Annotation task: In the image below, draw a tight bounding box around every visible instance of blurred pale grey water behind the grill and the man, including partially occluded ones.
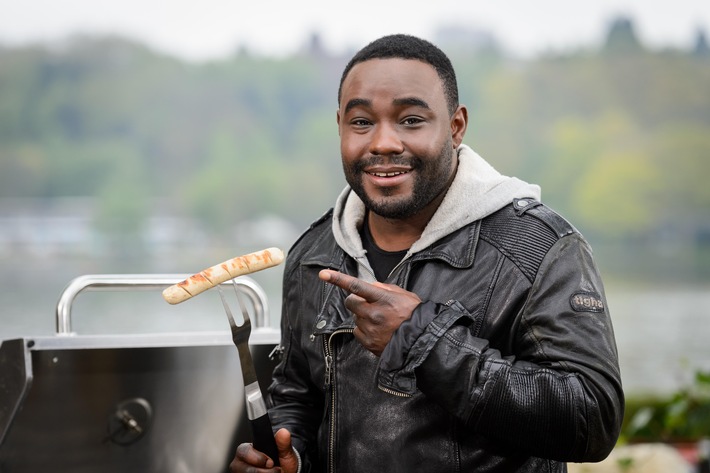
[0,251,710,394]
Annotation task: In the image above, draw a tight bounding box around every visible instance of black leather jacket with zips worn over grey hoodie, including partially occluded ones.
[270,200,624,473]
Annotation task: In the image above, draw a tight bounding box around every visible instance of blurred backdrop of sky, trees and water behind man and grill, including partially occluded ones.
[0,0,710,394]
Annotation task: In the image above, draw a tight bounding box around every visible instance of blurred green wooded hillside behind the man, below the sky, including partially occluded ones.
[0,21,710,276]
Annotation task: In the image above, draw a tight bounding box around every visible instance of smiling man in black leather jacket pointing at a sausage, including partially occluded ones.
[231,35,623,473]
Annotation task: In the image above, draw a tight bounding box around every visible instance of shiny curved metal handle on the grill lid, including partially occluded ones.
[57,274,269,335]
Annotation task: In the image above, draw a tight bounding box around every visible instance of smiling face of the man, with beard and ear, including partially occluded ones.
[338,59,465,219]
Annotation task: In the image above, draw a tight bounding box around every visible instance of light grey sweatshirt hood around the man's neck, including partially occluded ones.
[332,145,540,281]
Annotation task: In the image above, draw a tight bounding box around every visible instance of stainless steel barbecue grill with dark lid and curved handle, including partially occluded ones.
[0,275,279,473]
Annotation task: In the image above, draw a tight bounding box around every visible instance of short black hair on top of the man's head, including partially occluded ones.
[338,34,459,115]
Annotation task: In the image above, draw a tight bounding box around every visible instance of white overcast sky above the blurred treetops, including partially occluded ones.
[0,0,710,59]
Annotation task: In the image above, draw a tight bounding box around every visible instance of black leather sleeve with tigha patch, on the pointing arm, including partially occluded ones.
[379,232,624,462]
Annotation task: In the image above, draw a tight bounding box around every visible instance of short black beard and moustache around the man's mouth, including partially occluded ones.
[343,137,454,220]
